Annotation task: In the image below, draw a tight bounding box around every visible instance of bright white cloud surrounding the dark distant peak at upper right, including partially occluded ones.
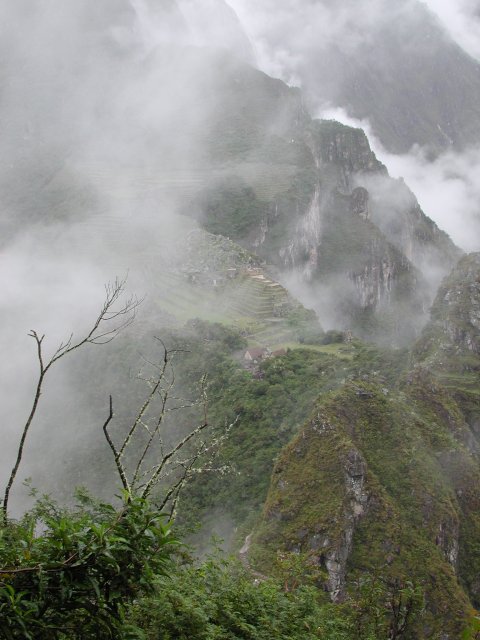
[231,0,480,251]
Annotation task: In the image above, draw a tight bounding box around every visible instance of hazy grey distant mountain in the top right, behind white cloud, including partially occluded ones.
[228,0,480,154]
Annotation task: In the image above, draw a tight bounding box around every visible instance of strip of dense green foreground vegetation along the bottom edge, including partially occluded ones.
[0,493,428,640]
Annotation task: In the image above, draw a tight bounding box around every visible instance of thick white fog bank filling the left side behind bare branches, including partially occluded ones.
[0,0,250,510]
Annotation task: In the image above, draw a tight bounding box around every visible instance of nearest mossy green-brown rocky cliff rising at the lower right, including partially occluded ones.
[251,255,480,640]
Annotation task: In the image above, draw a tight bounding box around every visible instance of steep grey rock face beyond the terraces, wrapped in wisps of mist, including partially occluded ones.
[274,121,450,342]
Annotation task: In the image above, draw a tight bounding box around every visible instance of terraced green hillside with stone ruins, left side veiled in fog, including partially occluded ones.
[58,210,321,348]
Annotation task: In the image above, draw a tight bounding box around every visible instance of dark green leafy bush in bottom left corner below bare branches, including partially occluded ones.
[0,495,176,640]
